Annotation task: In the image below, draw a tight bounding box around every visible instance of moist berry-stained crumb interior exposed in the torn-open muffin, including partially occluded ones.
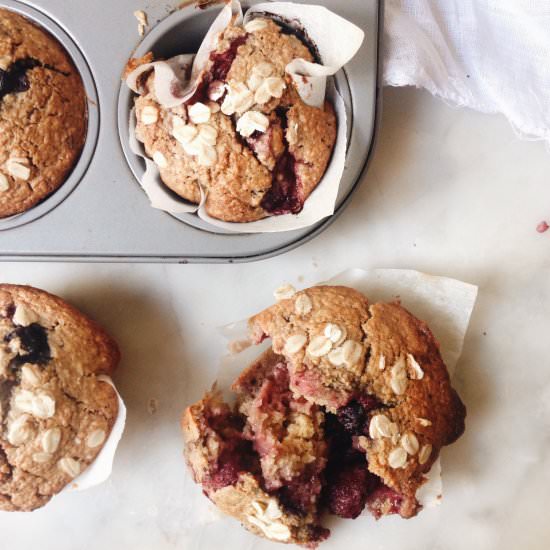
[187,356,426,546]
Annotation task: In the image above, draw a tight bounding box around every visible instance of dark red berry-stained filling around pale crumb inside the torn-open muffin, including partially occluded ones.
[204,378,412,540]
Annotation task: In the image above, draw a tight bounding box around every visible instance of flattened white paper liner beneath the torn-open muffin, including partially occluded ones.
[217,269,477,508]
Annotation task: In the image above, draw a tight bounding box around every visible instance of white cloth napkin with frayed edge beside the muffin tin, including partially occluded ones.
[384,0,550,147]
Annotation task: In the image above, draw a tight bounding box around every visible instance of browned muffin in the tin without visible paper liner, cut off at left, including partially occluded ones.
[0,9,87,218]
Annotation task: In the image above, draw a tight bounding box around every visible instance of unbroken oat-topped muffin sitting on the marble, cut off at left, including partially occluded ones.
[0,284,119,511]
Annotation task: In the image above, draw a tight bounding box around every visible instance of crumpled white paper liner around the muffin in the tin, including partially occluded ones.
[126,0,364,233]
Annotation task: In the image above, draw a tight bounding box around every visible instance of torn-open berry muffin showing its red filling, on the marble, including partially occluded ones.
[182,286,466,546]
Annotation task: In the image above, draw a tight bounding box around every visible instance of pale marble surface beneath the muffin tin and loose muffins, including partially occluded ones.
[0,89,550,550]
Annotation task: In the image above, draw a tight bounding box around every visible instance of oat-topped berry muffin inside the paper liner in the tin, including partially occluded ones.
[133,18,336,222]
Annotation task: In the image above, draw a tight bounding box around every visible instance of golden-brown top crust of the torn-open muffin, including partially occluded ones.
[249,286,466,504]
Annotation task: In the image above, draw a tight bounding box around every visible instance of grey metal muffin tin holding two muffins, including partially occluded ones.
[0,0,382,263]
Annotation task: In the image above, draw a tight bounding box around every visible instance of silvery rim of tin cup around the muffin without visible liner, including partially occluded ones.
[0,0,99,231]
